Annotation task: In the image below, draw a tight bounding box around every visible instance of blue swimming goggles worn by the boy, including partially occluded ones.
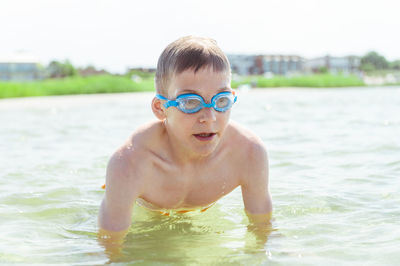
[156,91,237,114]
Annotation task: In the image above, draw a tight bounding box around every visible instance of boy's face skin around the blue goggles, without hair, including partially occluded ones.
[165,68,232,157]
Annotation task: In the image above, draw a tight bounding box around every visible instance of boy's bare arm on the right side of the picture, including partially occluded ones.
[241,143,272,218]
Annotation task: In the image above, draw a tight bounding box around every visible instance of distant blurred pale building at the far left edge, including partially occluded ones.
[0,54,42,81]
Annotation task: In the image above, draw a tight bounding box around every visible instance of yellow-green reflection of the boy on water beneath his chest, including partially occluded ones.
[101,206,272,265]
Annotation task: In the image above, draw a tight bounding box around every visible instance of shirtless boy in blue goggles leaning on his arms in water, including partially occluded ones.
[99,36,272,234]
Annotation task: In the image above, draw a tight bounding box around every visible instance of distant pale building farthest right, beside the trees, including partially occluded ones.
[305,55,361,73]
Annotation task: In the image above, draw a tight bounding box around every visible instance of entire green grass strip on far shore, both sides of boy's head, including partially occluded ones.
[0,74,365,98]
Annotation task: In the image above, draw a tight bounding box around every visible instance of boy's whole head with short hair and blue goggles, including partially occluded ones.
[152,36,236,157]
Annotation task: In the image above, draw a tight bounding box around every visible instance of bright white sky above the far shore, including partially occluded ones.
[0,0,400,73]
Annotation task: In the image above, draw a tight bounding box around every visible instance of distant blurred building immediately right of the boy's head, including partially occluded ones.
[228,55,304,75]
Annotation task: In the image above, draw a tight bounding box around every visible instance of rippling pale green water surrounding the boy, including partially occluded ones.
[0,87,400,265]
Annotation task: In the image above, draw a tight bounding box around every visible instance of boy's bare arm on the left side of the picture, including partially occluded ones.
[99,153,139,234]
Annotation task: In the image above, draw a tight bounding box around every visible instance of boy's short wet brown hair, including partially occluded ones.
[155,36,231,97]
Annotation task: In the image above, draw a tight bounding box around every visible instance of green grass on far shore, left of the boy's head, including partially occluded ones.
[0,75,154,98]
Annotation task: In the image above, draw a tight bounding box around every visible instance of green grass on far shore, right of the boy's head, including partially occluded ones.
[232,74,365,88]
